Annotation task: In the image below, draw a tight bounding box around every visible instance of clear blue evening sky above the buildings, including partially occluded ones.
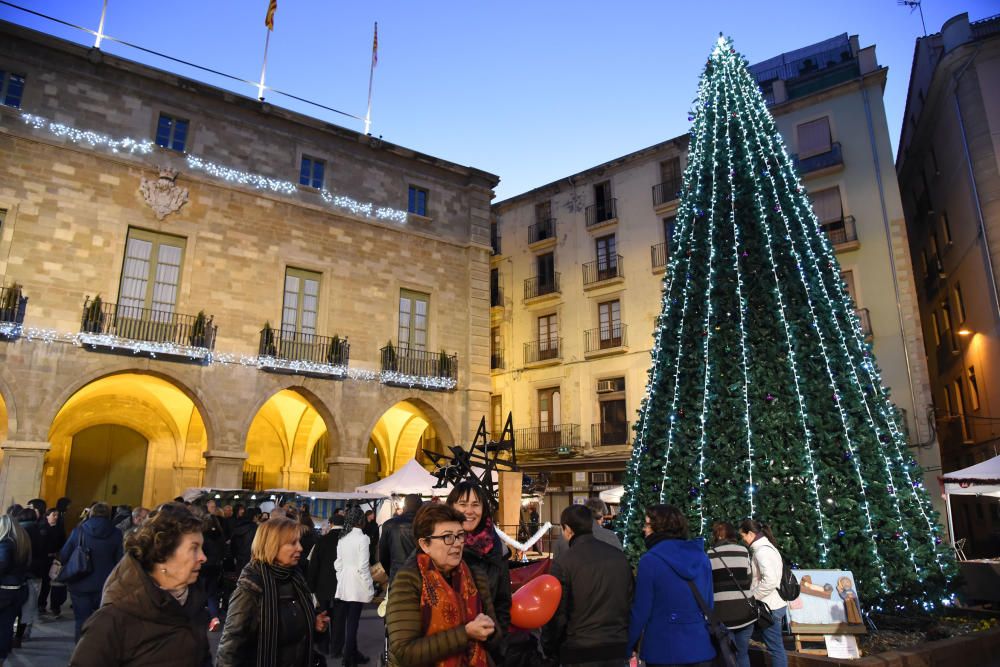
[0,0,1000,199]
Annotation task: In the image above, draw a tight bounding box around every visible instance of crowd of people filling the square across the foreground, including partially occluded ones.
[0,483,787,667]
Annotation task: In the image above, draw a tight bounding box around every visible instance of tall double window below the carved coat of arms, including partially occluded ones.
[118,229,185,321]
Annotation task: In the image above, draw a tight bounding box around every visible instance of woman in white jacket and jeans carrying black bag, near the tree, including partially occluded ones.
[740,519,788,667]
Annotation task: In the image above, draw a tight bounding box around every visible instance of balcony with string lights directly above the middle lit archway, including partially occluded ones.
[257,326,351,379]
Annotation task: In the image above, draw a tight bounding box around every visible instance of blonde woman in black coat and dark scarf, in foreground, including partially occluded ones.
[216,517,328,667]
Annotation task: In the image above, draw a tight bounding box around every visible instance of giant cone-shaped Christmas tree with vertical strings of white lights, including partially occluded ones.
[619,37,954,607]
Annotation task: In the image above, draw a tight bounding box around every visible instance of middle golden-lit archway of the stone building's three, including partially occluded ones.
[243,389,333,491]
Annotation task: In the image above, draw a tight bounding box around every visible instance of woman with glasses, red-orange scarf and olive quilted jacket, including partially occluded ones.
[386,503,502,667]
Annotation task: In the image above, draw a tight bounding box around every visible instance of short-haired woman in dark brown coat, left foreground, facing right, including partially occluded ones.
[69,502,212,667]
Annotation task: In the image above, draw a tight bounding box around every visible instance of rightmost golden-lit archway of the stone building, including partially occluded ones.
[365,399,455,481]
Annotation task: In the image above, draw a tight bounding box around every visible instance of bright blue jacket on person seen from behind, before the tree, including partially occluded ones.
[628,538,715,664]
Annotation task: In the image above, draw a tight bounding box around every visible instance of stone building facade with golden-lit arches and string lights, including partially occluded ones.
[0,23,498,505]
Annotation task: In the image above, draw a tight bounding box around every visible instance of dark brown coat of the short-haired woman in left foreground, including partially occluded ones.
[69,555,212,667]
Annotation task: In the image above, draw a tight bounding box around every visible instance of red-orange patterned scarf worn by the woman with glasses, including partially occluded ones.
[417,553,488,667]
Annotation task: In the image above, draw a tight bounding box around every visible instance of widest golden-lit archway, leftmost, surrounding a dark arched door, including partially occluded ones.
[42,372,208,507]
